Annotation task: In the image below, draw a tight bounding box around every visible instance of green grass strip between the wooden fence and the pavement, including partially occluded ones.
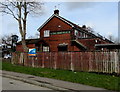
[2,62,120,91]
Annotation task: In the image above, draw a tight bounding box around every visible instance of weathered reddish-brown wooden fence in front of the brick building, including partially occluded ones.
[12,51,120,74]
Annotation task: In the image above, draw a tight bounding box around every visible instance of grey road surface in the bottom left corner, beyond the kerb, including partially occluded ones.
[0,76,52,90]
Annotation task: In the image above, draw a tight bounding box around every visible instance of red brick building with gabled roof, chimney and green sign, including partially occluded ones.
[16,10,113,52]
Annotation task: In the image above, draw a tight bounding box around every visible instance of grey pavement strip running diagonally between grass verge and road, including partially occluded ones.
[1,71,113,92]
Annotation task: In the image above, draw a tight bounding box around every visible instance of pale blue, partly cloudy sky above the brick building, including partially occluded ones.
[0,1,118,41]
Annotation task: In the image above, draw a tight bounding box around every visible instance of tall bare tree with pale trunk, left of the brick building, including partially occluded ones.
[0,0,43,52]
